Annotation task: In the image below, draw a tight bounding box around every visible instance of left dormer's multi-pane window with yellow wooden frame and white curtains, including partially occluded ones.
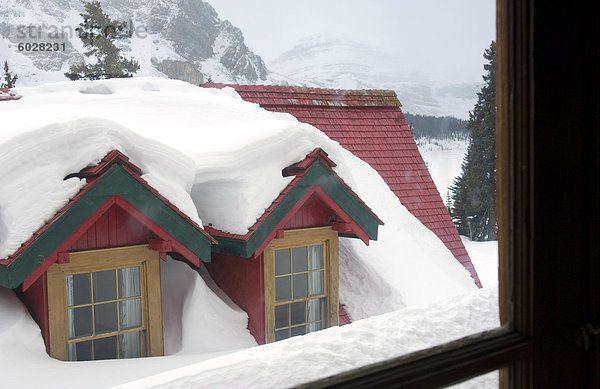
[48,246,163,361]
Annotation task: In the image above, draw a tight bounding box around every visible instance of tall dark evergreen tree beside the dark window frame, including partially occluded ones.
[450,42,498,240]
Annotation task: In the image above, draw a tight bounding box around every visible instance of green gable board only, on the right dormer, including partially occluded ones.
[212,161,379,258]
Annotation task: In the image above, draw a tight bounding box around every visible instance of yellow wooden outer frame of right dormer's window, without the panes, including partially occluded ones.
[263,227,340,343]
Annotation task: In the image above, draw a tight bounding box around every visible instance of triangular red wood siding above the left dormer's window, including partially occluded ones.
[69,204,155,251]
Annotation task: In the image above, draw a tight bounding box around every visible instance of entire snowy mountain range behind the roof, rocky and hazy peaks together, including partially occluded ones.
[0,0,481,119]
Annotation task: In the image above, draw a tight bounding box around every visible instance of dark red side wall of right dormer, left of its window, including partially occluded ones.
[205,253,265,344]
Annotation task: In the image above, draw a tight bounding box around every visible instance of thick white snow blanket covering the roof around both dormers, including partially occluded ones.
[0,78,474,310]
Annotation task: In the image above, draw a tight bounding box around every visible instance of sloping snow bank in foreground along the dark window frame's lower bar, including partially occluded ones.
[118,289,499,389]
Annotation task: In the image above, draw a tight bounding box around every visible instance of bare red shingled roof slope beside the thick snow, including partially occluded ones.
[203,84,481,287]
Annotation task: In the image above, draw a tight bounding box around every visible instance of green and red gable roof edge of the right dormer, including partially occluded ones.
[206,148,383,258]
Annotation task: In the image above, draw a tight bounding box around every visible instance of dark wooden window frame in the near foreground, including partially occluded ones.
[305,0,600,389]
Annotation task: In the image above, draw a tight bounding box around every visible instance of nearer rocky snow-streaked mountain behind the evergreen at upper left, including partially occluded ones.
[0,0,267,85]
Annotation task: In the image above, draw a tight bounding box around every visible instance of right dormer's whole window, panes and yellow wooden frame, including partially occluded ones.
[264,227,339,342]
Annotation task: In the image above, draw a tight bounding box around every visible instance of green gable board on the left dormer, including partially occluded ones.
[0,164,212,289]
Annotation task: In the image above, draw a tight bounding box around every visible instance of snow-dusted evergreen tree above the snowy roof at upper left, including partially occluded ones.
[65,1,140,80]
